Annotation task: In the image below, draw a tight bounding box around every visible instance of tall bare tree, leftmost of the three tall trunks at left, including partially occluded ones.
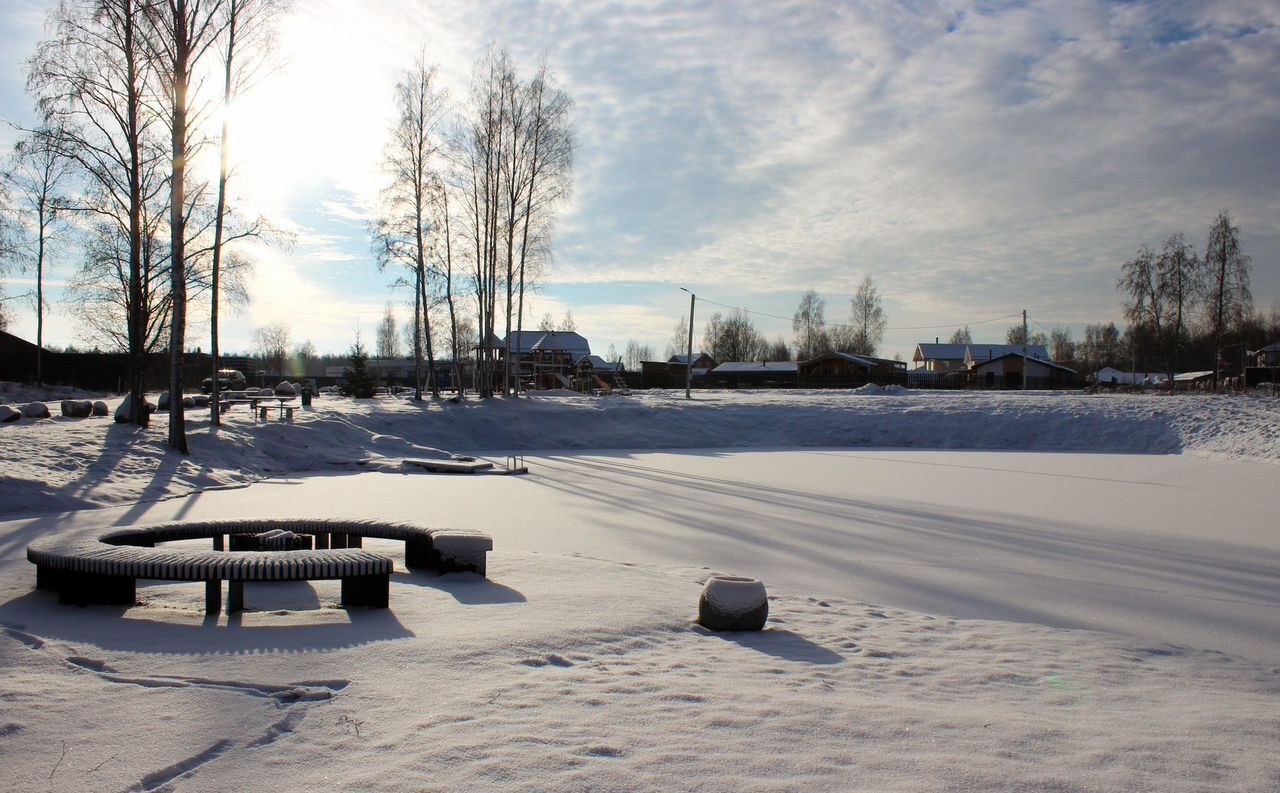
[27,0,163,425]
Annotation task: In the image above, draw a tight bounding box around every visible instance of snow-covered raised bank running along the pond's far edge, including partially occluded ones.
[0,389,1280,514]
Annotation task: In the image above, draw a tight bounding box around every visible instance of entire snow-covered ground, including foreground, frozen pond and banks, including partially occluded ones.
[0,393,1280,792]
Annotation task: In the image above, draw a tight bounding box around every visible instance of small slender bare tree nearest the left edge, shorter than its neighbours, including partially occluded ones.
[4,128,72,384]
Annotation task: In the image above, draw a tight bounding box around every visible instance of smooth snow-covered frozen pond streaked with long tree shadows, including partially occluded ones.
[10,450,1280,664]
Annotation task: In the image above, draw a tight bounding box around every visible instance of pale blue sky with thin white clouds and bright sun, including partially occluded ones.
[0,0,1280,359]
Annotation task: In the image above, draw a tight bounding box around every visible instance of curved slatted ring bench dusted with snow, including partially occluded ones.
[27,519,493,614]
